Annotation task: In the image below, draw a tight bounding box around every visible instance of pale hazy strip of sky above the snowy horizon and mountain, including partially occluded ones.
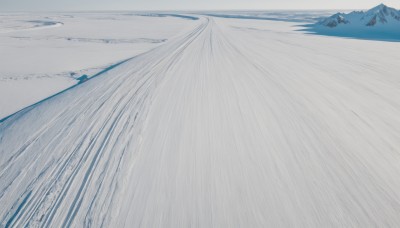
[0,0,400,11]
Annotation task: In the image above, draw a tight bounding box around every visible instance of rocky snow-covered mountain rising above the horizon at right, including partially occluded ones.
[319,4,400,28]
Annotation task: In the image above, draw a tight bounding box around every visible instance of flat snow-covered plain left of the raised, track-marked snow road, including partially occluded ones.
[0,12,195,119]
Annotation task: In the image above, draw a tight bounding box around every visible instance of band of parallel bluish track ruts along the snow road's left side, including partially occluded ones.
[1,17,207,226]
